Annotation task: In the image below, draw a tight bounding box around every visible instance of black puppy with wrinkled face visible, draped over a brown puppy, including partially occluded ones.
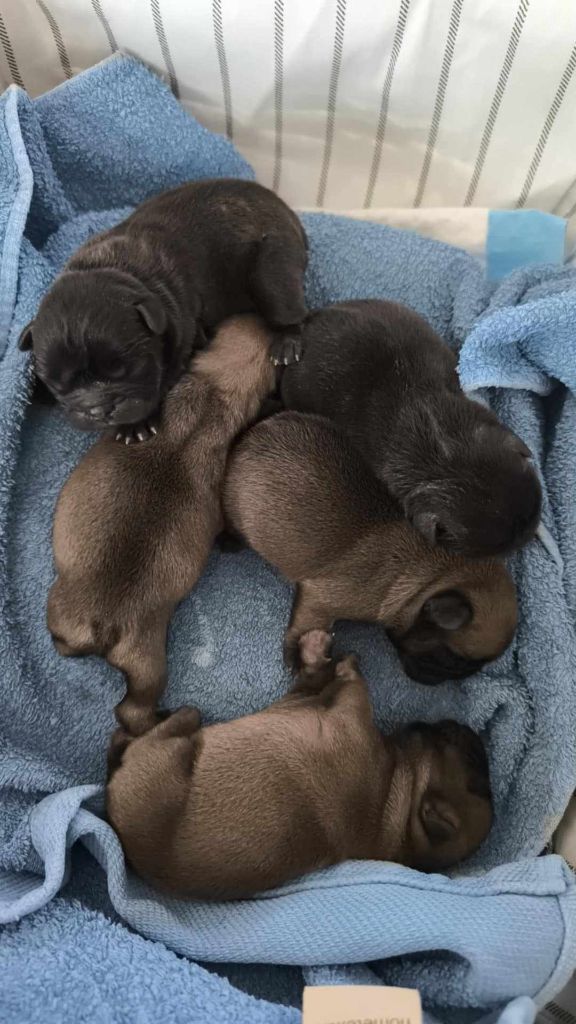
[20,178,307,441]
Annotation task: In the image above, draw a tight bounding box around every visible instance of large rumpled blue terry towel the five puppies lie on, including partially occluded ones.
[0,57,576,1022]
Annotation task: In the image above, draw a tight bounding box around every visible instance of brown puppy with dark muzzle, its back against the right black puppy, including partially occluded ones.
[223,413,517,683]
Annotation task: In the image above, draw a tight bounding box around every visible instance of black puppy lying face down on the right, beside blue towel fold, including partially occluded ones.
[282,300,541,557]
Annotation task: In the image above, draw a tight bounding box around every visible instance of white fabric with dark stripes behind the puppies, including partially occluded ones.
[0,0,576,216]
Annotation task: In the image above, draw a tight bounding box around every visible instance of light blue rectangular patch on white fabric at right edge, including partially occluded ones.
[486,210,566,281]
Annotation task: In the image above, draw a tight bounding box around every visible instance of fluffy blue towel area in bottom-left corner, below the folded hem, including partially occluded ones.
[0,899,535,1024]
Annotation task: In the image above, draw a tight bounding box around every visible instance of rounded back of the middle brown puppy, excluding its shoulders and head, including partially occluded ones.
[223,413,401,580]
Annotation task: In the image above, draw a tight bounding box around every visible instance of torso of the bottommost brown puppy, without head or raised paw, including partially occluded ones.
[107,696,384,899]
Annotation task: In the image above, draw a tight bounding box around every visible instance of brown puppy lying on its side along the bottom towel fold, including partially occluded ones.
[107,631,492,899]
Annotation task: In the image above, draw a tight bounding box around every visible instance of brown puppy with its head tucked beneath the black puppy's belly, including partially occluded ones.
[48,315,275,734]
